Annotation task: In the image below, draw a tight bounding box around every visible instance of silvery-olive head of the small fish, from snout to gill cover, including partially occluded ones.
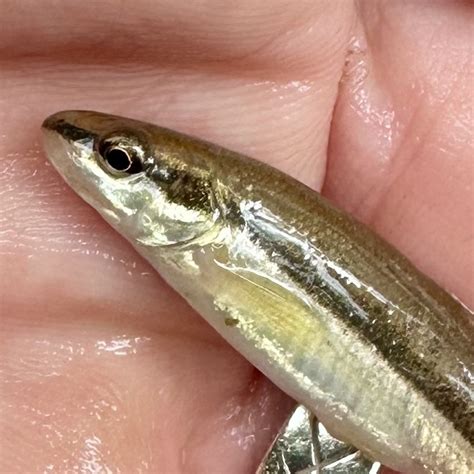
[42,111,220,247]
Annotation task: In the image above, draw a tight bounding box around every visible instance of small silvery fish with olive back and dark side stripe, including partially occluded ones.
[43,111,474,474]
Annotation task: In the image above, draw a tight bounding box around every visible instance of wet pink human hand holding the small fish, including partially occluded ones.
[0,0,474,474]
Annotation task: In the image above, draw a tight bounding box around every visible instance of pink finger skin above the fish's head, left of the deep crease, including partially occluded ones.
[0,0,353,187]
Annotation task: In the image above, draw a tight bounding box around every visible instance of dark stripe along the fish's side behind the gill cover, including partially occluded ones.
[246,216,474,444]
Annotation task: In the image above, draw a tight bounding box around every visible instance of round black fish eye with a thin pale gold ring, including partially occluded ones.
[98,139,143,176]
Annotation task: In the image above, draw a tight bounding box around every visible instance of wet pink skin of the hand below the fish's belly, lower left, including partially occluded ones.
[0,131,291,472]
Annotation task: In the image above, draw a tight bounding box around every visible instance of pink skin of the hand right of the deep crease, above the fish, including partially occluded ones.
[324,2,474,307]
